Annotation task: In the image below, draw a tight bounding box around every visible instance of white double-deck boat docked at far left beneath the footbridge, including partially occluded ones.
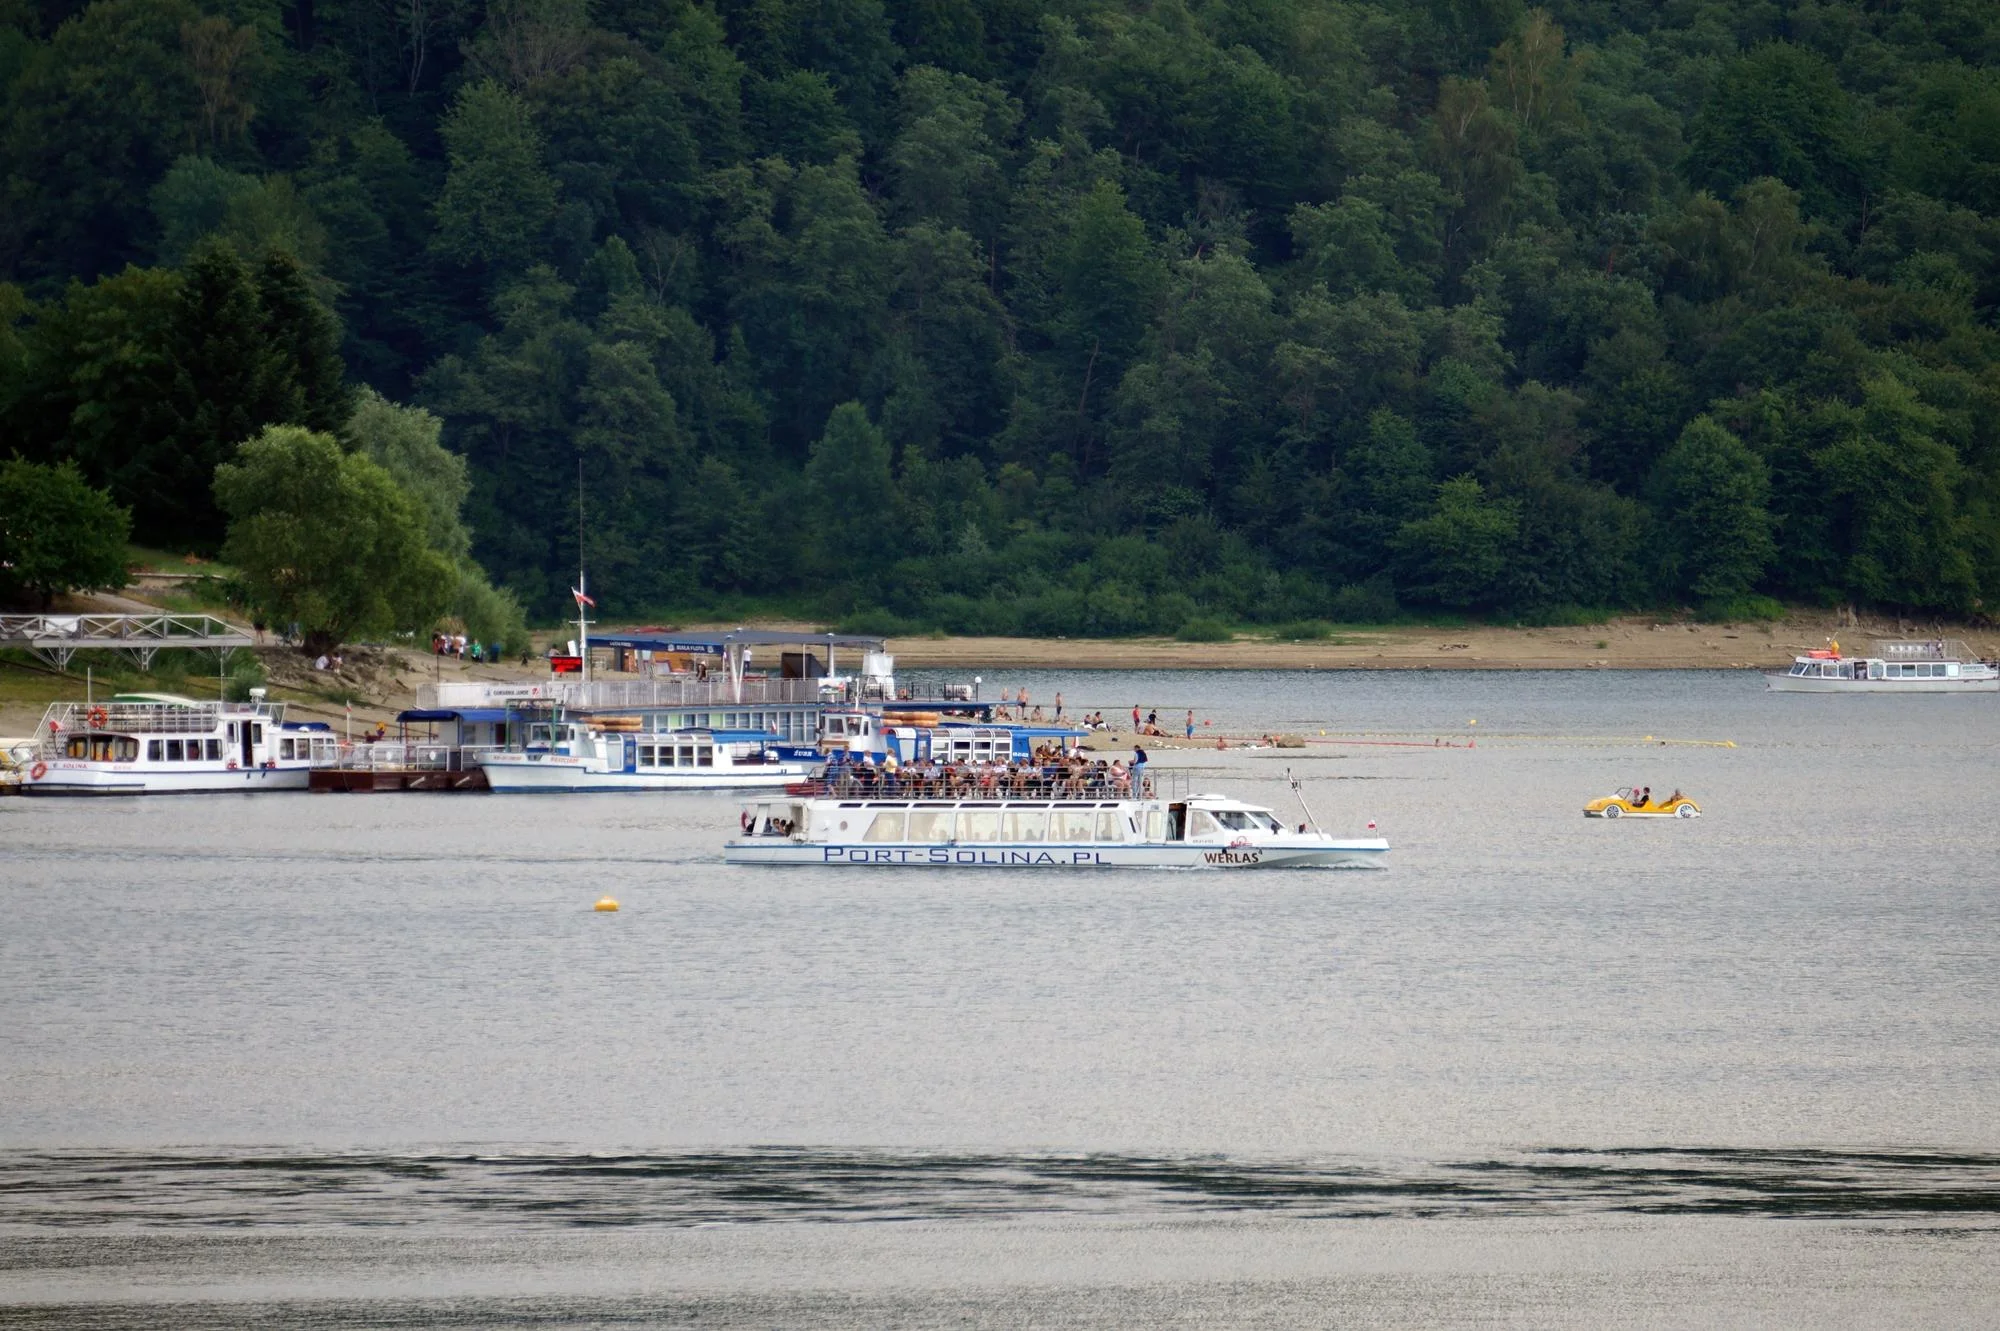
[22,689,338,795]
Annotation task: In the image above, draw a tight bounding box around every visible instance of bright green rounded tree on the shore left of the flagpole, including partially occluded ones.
[214,426,458,656]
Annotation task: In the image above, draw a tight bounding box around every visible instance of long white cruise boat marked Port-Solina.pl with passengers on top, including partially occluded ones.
[722,777,1388,869]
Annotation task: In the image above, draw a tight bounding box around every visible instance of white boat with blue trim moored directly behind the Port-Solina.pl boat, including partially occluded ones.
[478,717,820,793]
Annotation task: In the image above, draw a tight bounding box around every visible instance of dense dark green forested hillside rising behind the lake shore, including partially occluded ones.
[0,0,2000,634]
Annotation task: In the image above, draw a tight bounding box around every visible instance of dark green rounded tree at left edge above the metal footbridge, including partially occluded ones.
[0,458,132,610]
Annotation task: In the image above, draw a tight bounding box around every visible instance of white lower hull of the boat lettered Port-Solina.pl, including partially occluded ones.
[722,837,1388,869]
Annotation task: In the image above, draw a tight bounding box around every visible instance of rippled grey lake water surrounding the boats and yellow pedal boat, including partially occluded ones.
[0,671,2000,1327]
